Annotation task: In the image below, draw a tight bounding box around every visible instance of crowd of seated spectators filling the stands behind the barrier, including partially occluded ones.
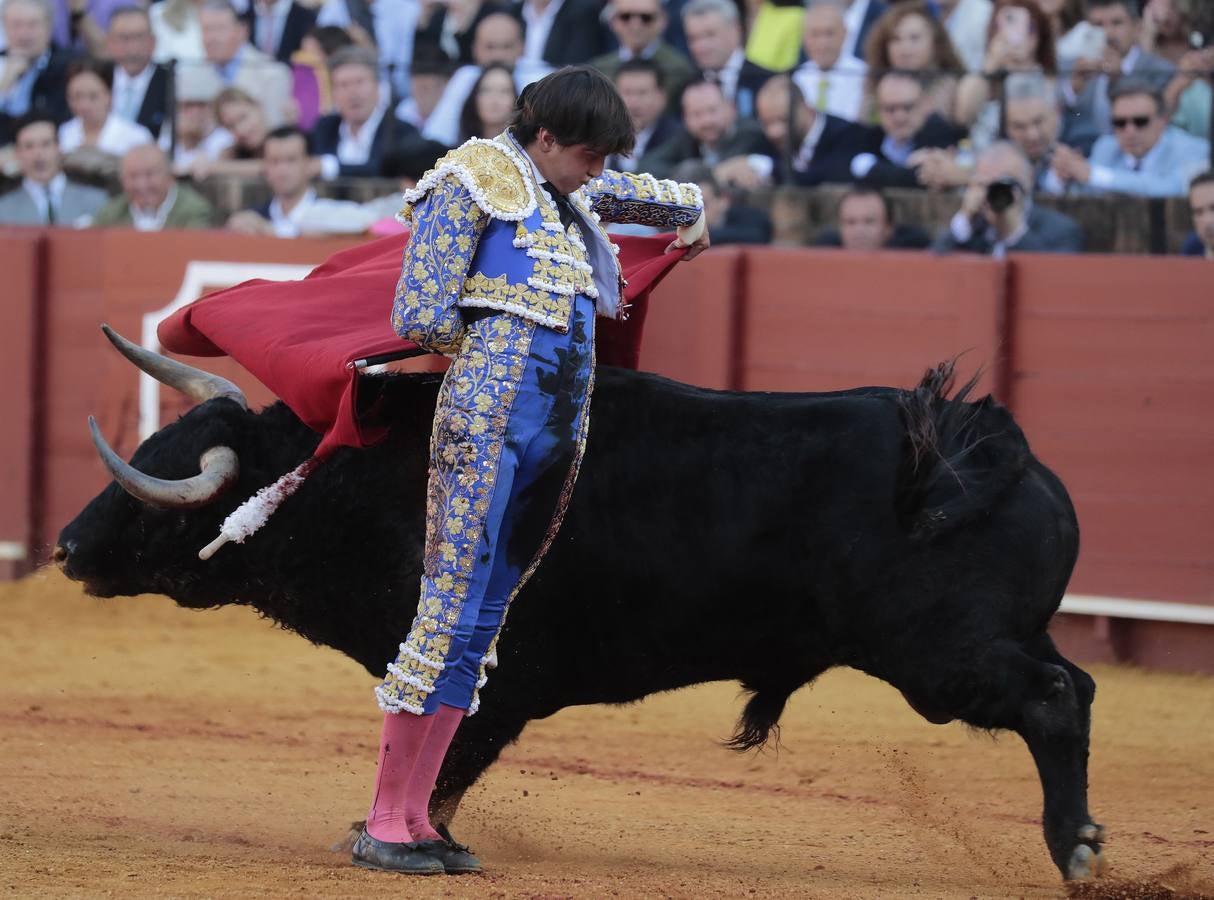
[0,0,1214,256]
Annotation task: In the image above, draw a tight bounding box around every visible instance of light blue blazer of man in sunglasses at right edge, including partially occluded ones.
[1083,125,1210,197]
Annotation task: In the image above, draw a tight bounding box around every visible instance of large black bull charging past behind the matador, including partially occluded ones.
[56,357,1104,878]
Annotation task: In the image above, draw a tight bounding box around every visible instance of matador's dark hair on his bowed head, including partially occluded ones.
[510,66,636,155]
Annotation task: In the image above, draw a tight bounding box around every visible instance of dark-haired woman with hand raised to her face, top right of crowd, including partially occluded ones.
[954,0,1057,151]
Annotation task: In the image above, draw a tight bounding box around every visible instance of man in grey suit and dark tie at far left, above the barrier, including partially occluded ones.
[0,113,107,227]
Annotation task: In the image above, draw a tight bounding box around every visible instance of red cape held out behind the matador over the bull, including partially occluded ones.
[157,234,685,457]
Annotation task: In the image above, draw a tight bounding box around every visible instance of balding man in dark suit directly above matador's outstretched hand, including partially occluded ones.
[636,80,771,179]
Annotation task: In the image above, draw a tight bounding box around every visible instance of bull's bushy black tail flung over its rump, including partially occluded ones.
[896,360,1031,542]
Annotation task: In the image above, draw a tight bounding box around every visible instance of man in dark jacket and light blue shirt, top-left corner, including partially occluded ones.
[0,0,72,147]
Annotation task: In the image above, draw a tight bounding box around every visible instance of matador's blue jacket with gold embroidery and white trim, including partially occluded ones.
[392,134,703,353]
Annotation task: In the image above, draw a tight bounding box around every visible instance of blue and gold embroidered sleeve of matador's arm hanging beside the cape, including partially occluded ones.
[392,177,489,355]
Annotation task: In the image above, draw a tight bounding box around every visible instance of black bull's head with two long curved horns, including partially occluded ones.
[53,326,279,606]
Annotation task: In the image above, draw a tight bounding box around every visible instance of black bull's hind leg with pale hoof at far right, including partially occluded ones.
[1016,634,1105,879]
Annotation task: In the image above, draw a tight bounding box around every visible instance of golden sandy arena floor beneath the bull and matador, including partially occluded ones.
[0,572,1214,900]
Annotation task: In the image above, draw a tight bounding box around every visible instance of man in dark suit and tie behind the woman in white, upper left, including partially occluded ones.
[106,6,169,137]
